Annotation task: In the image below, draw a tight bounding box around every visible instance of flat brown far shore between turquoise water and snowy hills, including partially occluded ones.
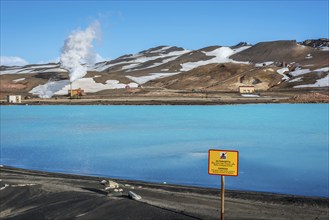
[0,88,329,105]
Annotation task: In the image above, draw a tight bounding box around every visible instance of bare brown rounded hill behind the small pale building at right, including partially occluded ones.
[145,63,282,91]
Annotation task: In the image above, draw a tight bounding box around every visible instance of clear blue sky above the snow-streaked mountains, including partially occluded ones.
[1,0,329,63]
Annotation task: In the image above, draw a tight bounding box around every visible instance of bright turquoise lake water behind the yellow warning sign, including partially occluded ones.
[1,104,329,197]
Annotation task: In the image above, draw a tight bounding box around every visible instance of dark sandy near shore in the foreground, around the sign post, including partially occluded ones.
[0,166,329,219]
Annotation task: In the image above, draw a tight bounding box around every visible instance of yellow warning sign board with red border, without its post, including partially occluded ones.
[208,150,239,176]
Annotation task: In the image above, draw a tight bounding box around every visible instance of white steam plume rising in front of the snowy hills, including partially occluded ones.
[60,21,99,82]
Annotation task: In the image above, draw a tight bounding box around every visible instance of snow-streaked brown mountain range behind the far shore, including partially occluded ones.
[0,39,329,97]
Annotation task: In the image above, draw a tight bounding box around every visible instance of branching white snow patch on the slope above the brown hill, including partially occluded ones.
[180,46,251,71]
